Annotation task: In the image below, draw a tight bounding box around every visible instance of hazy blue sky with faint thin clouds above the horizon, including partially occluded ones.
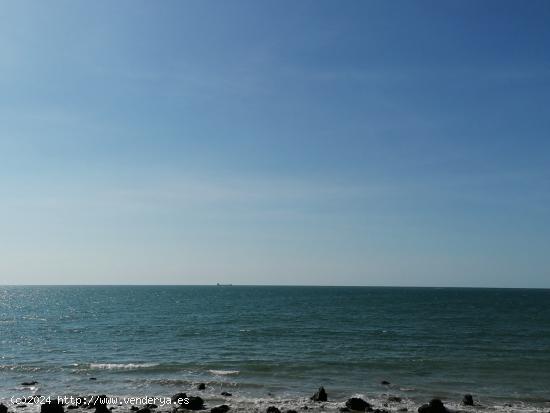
[0,0,550,288]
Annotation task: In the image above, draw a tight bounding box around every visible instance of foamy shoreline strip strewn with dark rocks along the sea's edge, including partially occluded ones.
[0,384,550,413]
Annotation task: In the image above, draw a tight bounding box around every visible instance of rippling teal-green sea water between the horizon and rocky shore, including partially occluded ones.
[0,286,550,411]
